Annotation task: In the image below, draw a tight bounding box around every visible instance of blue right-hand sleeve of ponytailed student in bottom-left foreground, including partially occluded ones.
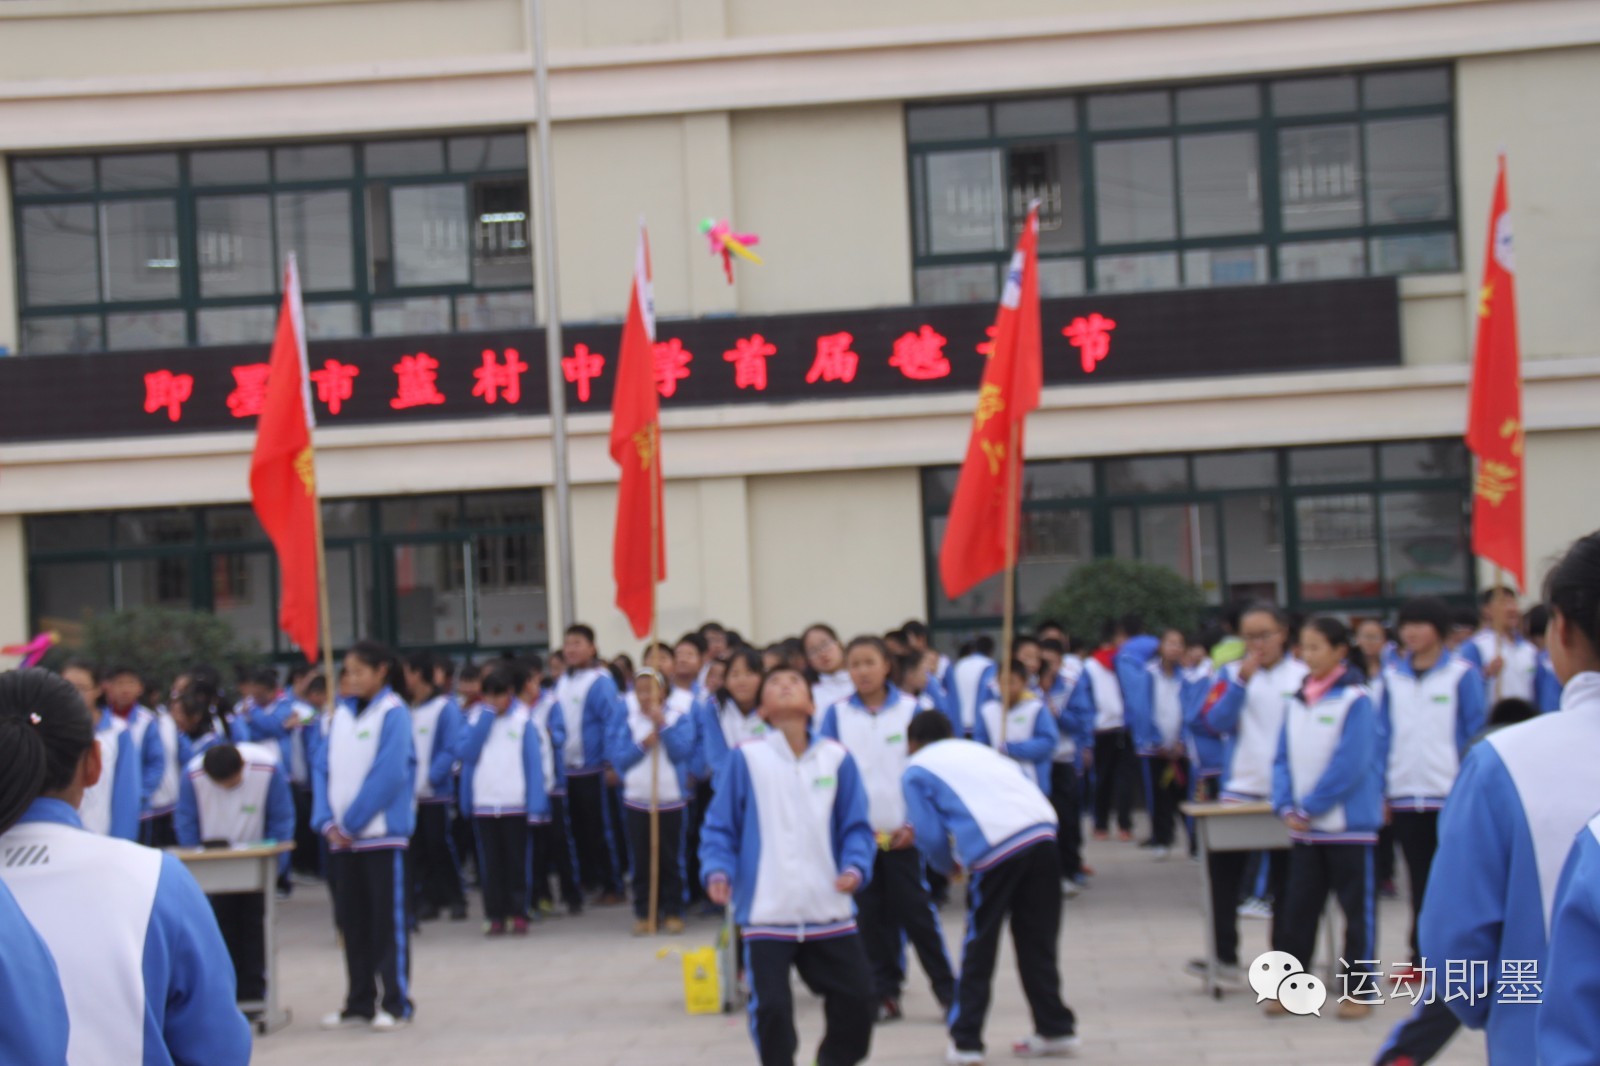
[144,855,250,1066]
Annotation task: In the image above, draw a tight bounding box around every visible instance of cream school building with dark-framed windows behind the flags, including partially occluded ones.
[0,0,1600,653]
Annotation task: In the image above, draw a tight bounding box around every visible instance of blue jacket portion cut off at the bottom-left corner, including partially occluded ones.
[0,877,67,1066]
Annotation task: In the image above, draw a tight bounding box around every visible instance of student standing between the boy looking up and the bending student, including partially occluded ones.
[818,637,955,1021]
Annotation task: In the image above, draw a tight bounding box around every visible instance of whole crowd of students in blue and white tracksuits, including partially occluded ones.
[0,533,1600,1066]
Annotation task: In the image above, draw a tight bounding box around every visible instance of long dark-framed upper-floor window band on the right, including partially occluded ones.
[906,67,1461,304]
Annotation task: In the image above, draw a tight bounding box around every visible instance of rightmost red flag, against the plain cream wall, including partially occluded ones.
[1467,155,1528,589]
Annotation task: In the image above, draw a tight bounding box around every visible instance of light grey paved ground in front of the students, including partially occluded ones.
[254,819,1483,1066]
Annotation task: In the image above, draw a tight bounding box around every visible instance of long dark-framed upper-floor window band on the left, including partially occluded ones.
[11,133,534,354]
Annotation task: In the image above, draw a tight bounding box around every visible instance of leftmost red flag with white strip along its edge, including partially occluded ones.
[250,254,322,663]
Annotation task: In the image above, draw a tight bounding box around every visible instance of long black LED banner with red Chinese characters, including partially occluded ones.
[0,279,1400,442]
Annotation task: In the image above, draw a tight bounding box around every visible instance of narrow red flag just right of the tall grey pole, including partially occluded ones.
[611,222,667,637]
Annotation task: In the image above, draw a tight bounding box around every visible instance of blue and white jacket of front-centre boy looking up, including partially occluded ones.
[699,730,877,941]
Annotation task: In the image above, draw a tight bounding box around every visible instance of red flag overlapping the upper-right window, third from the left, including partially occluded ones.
[939,206,1043,599]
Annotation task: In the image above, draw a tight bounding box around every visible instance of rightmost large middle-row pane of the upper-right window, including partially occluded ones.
[1366,115,1451,222]
